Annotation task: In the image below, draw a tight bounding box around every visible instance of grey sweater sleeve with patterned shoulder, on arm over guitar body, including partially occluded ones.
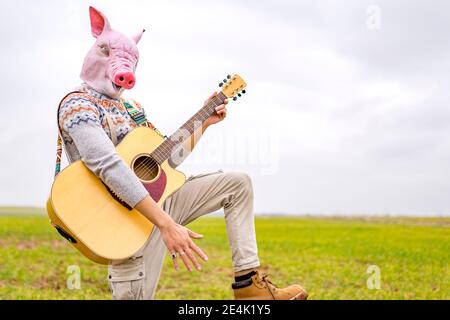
[58,99,148,208]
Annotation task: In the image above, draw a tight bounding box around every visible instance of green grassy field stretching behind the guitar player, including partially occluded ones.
[0,215,450,299]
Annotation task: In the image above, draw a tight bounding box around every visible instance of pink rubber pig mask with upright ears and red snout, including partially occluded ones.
[80,7,145,99]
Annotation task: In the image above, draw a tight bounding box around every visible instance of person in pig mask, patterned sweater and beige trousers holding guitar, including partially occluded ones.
[58,7,308,300]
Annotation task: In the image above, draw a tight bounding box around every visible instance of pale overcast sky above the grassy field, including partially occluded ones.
[0,0,450,215]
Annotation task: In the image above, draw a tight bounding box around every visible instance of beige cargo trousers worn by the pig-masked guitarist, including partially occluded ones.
[108,171,259,299]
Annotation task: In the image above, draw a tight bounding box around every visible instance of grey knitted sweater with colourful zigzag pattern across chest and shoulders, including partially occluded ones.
[58,84,155,207]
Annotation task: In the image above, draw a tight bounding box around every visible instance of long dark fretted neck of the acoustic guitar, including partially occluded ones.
[151,92,227,164]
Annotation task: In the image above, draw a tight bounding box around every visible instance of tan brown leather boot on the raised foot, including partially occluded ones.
[232,271,308,300]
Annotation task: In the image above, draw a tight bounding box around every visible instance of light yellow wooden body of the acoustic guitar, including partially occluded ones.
[47,127,186,264]
